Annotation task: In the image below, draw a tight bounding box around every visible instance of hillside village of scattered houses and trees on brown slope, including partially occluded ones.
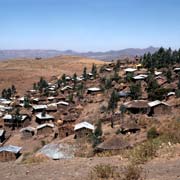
[0,48,180,177]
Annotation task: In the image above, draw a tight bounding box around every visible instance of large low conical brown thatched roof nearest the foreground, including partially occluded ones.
[96,135,130,151]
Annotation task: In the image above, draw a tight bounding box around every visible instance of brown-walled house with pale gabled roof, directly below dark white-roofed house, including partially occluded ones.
[36,123,54,135]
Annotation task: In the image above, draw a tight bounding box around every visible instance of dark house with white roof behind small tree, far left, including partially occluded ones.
[3,114,30,128]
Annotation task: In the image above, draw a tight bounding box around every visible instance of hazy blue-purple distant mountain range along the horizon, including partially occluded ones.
[0,47,158,61]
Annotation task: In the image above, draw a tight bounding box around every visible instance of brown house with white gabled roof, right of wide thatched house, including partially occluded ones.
[148,100,171,116]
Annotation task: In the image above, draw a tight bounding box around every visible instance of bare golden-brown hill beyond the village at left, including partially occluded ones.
[0,56,104,94]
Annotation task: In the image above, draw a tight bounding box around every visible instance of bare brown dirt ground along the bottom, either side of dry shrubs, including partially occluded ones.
[0,156,180,180]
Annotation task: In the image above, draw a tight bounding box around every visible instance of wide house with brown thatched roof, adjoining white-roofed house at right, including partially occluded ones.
[123,100,149,114]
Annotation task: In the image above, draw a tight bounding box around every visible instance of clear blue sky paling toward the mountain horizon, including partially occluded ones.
[0,0,180,51]
